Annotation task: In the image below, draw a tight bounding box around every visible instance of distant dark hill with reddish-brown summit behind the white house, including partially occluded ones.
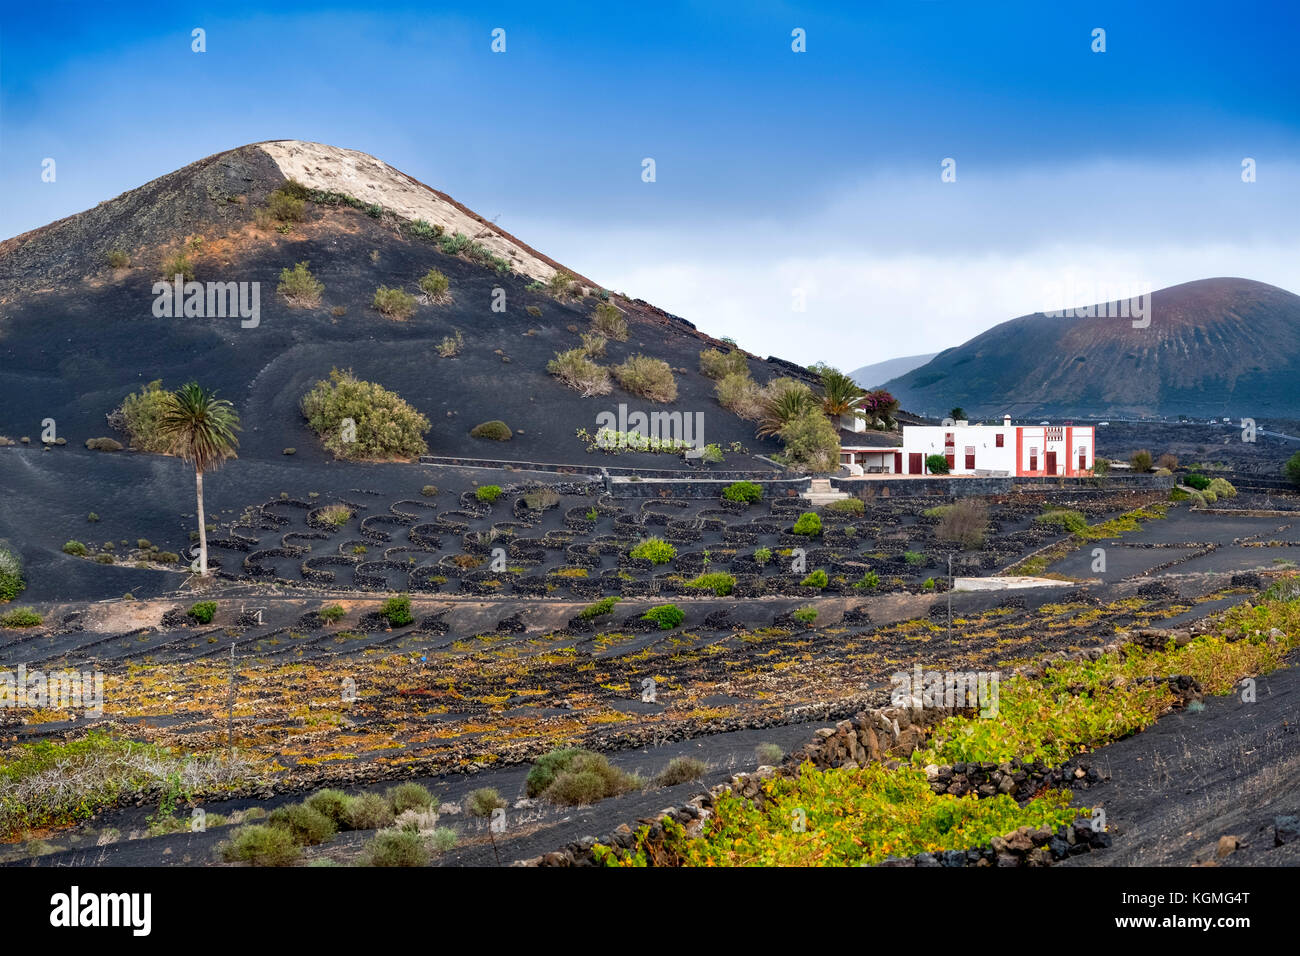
[885,278,1300,418]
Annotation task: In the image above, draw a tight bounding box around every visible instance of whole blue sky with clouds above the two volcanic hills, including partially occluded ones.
[0,0,1300,368]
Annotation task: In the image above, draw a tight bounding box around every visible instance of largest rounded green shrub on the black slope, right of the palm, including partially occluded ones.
[302,368,429,460]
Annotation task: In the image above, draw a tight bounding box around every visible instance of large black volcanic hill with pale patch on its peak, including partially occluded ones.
[0,140,805,467]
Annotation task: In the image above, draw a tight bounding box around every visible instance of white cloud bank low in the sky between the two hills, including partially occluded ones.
[511,163,1300,369]
